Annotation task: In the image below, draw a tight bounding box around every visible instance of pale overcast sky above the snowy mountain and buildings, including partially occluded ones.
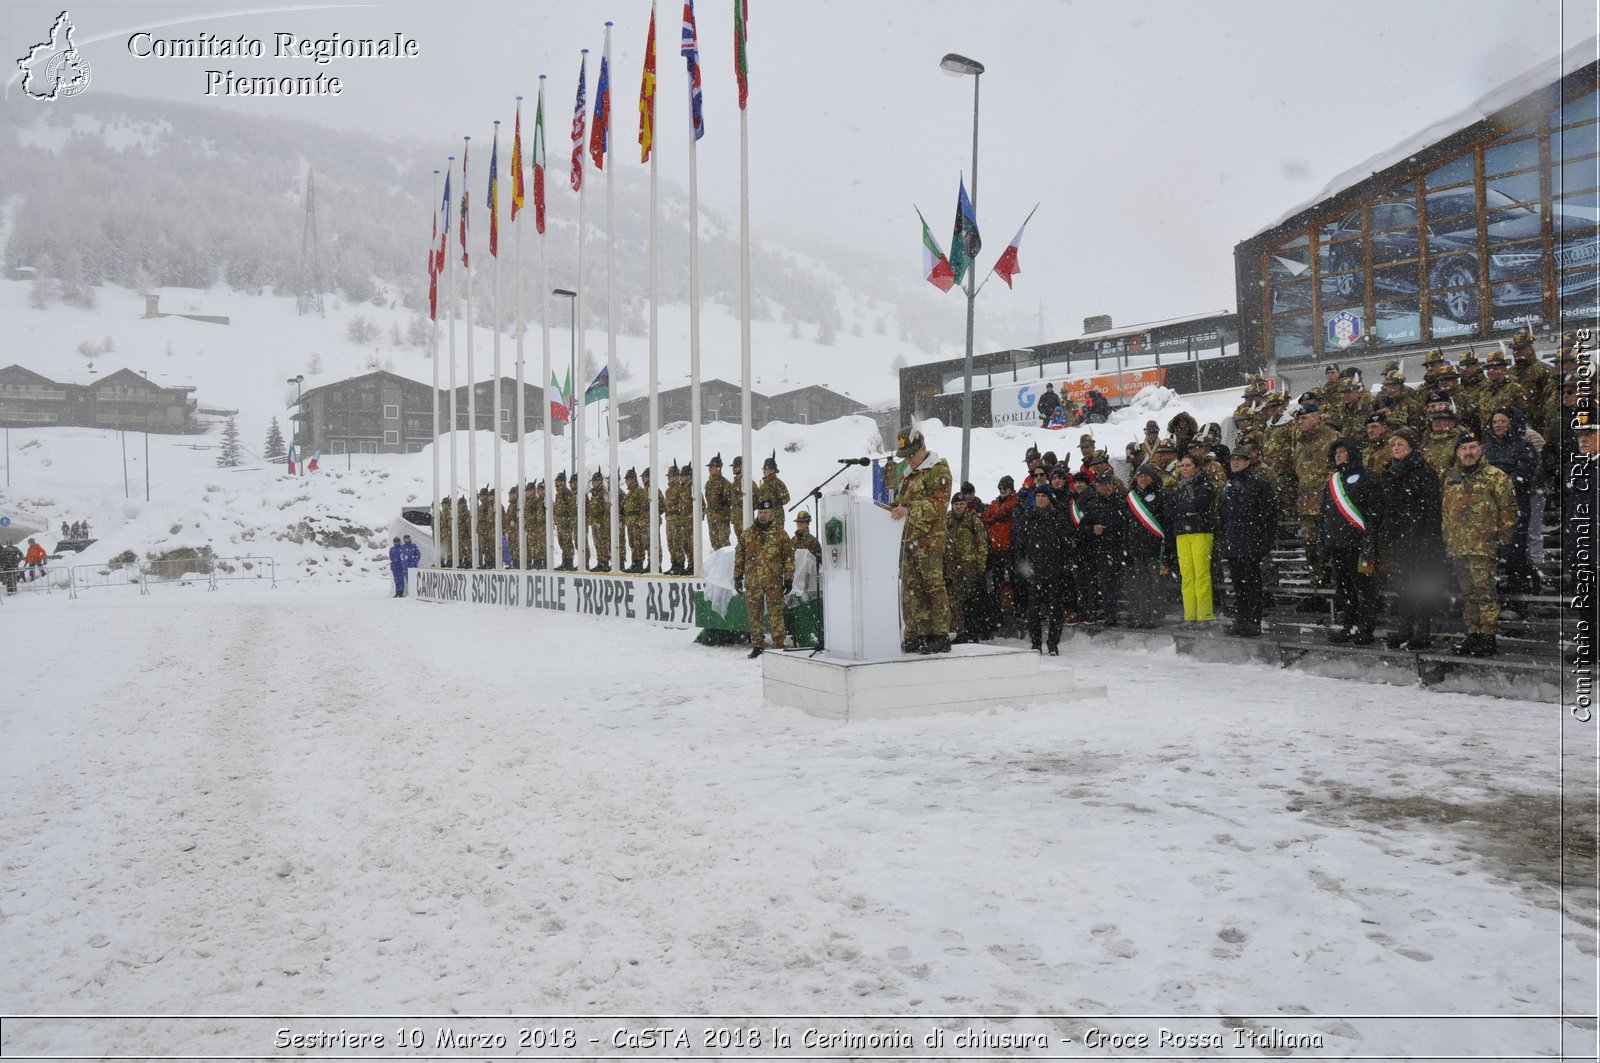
[0,0,1595,344]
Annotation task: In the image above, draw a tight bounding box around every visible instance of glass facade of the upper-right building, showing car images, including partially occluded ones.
[1240,64,1600,359]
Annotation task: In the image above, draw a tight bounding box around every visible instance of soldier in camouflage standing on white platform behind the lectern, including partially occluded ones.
[890,427,950,653]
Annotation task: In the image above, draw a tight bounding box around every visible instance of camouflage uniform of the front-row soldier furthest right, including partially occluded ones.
[1442,458,1517,634]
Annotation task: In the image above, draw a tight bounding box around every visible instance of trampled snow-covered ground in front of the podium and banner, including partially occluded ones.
[0,580,1597,1058]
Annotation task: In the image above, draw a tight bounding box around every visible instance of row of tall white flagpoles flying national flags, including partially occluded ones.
[427,0,752,573]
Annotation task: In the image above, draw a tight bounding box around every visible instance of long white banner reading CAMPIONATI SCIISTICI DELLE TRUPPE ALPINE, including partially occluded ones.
[411,568,706,628]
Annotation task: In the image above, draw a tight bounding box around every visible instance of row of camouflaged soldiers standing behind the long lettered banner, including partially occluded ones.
[438,455,789,575]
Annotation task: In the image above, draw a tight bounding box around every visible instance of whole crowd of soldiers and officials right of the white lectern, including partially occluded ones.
[857,333,1600,656]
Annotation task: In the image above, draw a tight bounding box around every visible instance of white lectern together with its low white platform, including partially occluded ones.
[762,493,1106,720]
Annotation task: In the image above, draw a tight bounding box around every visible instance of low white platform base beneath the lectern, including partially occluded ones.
[762,645,1106,720]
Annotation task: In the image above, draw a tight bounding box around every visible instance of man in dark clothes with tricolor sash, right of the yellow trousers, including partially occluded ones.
[1317,435,1381,645]
